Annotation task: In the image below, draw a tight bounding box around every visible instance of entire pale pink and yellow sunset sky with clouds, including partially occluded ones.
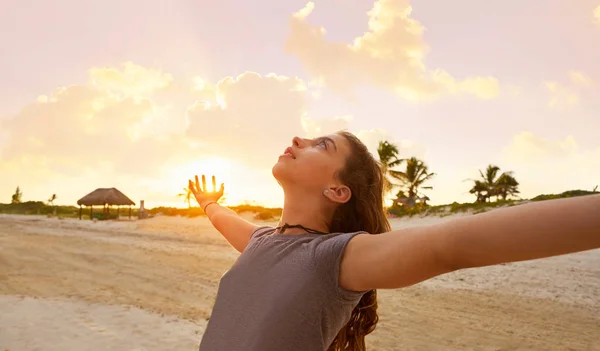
[0,0,600,207]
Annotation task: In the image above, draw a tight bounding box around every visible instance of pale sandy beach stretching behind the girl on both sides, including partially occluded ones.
[0,215,600,351]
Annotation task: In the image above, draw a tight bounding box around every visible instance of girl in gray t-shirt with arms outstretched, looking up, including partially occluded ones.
[189,132,600,351]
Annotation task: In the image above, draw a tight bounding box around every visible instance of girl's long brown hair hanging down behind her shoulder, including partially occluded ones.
[328,131,390,351]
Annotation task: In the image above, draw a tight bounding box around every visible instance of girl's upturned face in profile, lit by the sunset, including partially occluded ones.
[272,134,350,193]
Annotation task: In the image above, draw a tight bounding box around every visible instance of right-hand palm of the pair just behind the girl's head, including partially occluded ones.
[394,157,435,207]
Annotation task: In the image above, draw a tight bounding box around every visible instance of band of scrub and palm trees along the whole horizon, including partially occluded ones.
[0,141,599,220]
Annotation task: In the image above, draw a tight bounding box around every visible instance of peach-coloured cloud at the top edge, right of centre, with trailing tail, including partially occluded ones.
[286,0,500,101]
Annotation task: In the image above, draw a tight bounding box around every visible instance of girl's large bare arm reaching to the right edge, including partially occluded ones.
[340,195,600,291]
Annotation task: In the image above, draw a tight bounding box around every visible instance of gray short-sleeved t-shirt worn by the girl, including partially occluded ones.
[200,227,364,351]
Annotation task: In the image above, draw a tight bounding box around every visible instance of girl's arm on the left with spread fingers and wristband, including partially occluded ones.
[189,175,258,252]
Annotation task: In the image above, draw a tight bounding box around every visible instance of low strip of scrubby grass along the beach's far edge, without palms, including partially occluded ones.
[0,190,600,220]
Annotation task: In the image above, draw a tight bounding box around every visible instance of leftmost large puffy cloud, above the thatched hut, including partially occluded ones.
[0,63,195,194]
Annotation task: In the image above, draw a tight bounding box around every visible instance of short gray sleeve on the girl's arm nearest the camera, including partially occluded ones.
[314,232,366,302]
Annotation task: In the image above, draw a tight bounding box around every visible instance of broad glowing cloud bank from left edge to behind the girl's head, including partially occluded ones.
[0,64,432,206]
